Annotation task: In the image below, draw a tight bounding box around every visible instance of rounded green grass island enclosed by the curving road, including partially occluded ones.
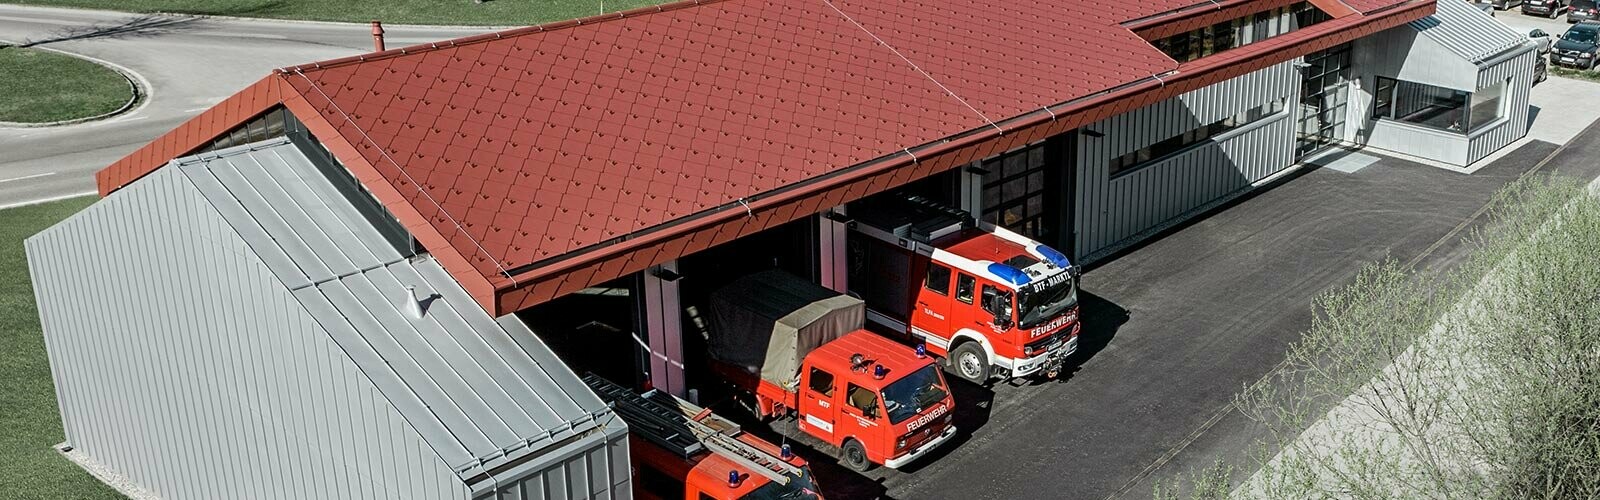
[0,46,133,123]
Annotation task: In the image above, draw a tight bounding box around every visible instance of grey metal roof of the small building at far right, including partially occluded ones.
[1406,0,1526,64]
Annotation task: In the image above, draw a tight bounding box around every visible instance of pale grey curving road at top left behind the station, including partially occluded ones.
[0,5,488,207]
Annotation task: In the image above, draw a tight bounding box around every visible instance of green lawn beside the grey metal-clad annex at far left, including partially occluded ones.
[0,197,120,498]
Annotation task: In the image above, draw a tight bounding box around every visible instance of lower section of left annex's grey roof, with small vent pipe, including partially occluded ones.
[294,256,610,481]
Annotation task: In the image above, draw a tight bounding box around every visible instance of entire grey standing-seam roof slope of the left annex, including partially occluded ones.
[174,139,610,482]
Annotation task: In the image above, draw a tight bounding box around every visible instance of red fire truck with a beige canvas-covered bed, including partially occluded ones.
[706,271,955,471]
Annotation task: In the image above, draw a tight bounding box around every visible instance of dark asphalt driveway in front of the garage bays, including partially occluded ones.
[771,119,1600,498]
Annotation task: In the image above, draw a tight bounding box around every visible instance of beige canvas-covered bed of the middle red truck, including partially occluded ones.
[706,269,866,391]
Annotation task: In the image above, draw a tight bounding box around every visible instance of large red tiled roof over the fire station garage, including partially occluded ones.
[99,0,1434,314]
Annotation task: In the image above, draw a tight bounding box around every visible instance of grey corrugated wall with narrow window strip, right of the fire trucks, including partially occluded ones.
[1074,61,1301,256]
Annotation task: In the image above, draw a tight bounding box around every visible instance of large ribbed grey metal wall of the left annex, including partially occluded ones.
[27,168,469,498]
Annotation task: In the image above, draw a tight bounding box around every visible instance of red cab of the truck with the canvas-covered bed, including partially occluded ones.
[795,330,955,471]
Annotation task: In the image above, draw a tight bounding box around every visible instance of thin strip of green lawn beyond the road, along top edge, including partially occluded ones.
[0,0,666,26]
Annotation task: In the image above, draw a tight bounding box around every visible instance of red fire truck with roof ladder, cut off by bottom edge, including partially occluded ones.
[582,373,822,500]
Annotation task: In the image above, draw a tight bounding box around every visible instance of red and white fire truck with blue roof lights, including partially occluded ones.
[848,196,1080,383]
